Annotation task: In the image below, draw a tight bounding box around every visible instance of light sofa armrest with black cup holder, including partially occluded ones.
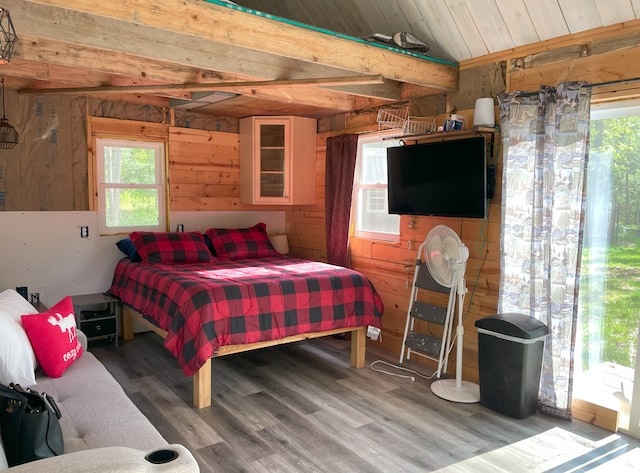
[4,444,200,473]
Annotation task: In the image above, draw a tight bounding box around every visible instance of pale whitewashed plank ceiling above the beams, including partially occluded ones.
[235,0,640,62]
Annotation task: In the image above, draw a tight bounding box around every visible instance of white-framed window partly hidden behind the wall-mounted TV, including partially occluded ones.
[352,135,400,240]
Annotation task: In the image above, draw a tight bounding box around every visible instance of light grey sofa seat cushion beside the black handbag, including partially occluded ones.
[36,352,167,453]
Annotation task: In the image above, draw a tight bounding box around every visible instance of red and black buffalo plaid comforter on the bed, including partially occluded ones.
[109,257,383,376]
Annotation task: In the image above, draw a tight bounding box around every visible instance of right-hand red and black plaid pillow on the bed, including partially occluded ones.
[206,222,280,261]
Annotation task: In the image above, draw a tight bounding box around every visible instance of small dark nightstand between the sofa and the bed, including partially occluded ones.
[71,292,120,346]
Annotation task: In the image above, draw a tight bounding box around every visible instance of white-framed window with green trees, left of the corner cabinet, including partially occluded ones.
[96,138,166,234]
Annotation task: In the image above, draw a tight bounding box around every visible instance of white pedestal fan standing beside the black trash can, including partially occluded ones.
[425,225,480,403]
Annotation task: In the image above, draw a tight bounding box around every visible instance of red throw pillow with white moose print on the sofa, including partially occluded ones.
[22,296,82,378]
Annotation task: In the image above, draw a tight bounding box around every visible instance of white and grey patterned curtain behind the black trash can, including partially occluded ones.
[498,82,591,419]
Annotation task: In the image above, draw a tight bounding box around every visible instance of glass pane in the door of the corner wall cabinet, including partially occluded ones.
[260,124,286,198]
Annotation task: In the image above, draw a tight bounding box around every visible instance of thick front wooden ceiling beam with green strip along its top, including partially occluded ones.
[23,0,457,90]
